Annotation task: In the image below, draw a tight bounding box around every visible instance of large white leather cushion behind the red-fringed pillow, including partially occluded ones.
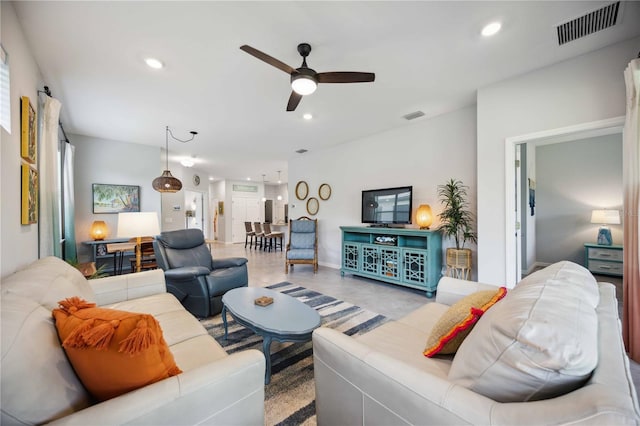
[449,261,599,402]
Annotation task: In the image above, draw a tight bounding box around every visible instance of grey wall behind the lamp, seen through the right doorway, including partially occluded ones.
[536,134,623,265]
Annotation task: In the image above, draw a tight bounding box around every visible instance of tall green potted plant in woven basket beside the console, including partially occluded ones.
[438,179,477,279]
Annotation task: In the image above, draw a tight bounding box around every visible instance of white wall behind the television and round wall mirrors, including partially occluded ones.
[288,107,476,274]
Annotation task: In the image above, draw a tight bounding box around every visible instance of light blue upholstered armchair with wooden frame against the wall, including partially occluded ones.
[284,216,318,274]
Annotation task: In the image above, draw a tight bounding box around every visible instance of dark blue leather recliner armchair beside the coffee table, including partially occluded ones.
[153,229,249,318]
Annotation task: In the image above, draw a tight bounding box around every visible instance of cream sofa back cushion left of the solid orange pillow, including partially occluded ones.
[0,294,91,424]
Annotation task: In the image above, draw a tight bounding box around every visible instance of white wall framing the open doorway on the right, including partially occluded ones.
[477,38,640,283]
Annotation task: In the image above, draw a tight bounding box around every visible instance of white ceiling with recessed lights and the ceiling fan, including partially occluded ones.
[14,1,640,182]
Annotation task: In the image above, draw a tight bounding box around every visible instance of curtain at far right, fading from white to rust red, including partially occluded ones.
[622,59,640,362]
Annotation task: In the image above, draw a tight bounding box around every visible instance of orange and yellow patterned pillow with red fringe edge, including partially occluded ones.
[423,287,507,358]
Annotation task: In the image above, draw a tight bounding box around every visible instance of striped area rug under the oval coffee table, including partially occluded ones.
[202,282,388,425]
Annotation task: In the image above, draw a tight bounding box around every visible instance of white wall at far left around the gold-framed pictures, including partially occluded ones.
[0,1,43,277]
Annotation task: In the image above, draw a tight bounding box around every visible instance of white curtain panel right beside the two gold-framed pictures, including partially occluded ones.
[38,96,62,258]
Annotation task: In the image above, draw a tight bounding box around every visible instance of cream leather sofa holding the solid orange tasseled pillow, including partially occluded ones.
[0,257,265,425]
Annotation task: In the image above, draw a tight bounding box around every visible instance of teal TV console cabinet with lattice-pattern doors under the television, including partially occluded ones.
[340,226,442,297]
